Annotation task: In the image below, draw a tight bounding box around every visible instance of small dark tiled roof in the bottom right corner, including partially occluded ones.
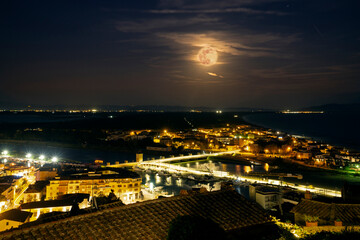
[291,199,360,225]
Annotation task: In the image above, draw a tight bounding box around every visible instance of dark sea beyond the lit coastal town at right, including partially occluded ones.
[243,112,360,151]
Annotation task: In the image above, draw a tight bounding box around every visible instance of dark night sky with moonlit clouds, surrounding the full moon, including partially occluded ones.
[0,0,360,108]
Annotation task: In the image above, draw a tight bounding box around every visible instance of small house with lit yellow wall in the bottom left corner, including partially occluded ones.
[0,209,32,232]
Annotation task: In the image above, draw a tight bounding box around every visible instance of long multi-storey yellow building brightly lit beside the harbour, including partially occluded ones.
[45,169,142,203]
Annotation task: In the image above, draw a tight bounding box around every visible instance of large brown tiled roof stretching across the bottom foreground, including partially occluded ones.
[0,190,272,239]
